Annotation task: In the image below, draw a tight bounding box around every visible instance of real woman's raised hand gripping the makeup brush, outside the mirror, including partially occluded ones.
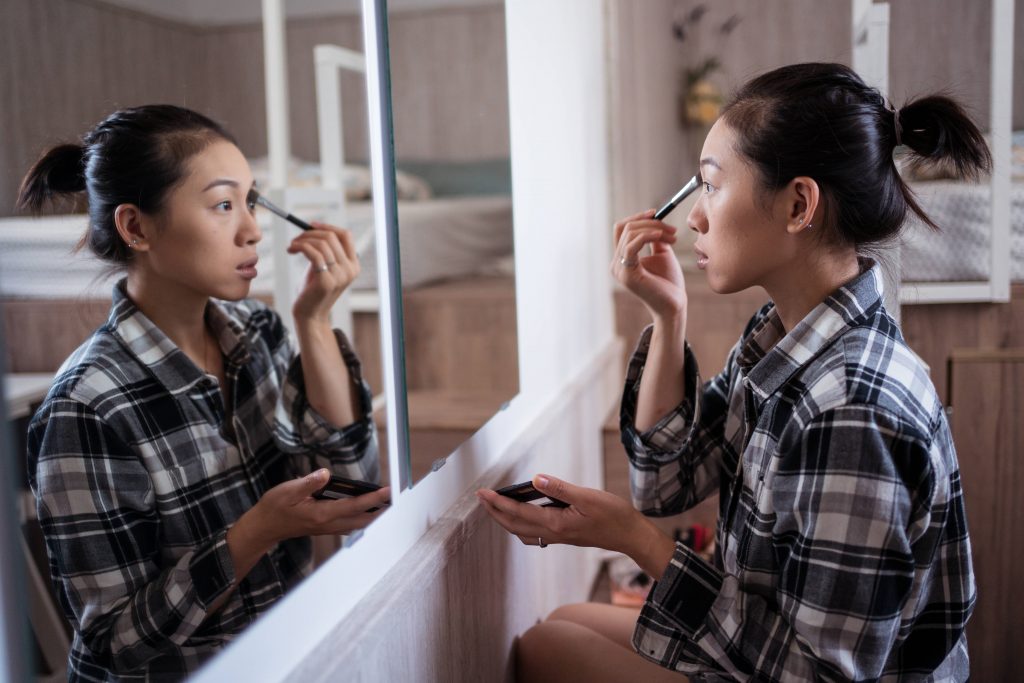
[611,209,686,319]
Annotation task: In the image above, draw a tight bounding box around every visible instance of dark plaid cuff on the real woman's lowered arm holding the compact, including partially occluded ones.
[633,543,725,669]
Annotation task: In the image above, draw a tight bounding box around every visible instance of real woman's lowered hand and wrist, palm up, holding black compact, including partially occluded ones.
[476,474,675,579]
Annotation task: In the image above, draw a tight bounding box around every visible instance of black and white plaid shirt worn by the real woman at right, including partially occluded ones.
[622,261,975,681]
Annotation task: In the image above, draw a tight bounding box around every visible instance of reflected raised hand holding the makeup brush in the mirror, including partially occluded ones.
[288,221,359,322]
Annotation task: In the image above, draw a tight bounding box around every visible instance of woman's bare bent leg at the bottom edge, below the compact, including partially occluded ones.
[516,620,686,683]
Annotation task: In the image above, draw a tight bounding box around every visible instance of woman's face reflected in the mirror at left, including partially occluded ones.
[146,140,262,301]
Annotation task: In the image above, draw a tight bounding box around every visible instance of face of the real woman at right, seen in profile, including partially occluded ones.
[686,119,794,294]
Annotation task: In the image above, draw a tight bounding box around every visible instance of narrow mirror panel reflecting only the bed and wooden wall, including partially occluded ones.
[387,0,519,484]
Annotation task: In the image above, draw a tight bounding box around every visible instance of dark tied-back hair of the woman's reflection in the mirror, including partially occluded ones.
[17,104,234,264]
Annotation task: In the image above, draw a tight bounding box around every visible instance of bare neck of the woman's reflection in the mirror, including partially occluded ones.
[128,270,209,362]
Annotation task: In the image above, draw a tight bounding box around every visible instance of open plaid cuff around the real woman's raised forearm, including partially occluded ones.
[620,326,700,458]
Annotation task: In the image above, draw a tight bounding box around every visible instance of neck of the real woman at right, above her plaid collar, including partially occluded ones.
[764,249,860,332]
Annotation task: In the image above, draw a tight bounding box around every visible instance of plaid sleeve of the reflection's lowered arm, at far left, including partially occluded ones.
[28,398,234,674]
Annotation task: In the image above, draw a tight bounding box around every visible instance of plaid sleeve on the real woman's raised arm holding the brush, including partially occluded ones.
[620,326,738,516]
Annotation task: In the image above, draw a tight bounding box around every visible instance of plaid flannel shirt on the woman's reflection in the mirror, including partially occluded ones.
[28,281,379,681]
